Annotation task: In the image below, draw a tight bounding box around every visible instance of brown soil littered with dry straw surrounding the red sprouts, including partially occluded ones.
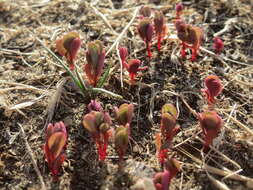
[0,0,253,190]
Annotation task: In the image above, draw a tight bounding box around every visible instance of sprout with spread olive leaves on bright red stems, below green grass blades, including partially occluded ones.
[83,111,112,161]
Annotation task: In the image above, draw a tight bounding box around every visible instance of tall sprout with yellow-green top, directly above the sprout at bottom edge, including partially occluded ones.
[156,104,180,164]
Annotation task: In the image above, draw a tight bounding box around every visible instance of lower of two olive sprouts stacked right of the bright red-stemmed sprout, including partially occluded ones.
[114,124,129,161]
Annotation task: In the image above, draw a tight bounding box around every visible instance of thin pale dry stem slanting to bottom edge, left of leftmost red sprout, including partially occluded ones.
[18,123,47,190]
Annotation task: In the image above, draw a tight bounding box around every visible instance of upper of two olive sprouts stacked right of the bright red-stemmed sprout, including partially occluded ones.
[114,104,134,126]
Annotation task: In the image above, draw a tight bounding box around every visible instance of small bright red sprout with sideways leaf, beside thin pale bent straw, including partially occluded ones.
[119,47,148,83]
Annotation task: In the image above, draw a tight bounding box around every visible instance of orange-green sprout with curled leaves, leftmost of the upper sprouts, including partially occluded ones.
[56,32,81,71]
